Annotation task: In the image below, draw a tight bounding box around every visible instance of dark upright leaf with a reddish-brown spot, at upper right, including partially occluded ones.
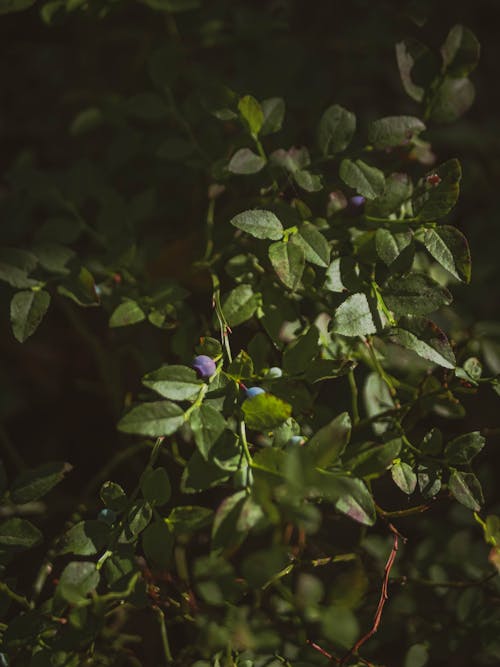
[411,159,462,221]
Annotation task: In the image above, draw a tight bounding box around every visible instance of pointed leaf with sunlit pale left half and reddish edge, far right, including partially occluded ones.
[416,225,471,283]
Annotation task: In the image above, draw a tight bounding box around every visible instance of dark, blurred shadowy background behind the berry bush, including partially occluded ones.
[0,0,500,664]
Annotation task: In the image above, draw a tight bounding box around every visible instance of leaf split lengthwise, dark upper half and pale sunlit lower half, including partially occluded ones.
[390,315,456,368]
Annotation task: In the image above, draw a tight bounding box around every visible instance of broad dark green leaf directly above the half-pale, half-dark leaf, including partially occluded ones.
[382,273,453,315]
